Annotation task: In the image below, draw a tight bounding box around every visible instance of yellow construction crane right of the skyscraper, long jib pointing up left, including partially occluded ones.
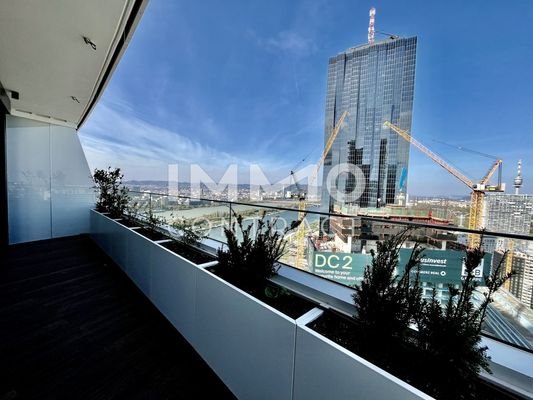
[383,121,505,247]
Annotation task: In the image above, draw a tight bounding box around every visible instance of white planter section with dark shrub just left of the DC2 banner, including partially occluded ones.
[191,213,314,399]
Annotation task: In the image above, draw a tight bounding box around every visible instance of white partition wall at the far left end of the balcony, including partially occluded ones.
[6,115,94,244]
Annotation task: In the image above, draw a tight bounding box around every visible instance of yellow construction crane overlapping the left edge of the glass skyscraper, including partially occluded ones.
[291,111,349,268]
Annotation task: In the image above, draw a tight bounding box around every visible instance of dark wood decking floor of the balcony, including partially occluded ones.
[0,236,234,400]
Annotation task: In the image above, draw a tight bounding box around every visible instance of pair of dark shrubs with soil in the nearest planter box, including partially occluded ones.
[309,229,513,399]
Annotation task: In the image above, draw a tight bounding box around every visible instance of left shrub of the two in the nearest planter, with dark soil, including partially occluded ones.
[309,228,424,390]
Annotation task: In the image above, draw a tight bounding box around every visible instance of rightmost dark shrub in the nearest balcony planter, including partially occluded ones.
[417,241,514,399]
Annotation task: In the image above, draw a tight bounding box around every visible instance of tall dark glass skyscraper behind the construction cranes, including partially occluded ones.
[322,37,417,211]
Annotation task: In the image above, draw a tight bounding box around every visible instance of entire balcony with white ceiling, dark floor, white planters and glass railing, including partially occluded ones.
[0,0,533,399]
